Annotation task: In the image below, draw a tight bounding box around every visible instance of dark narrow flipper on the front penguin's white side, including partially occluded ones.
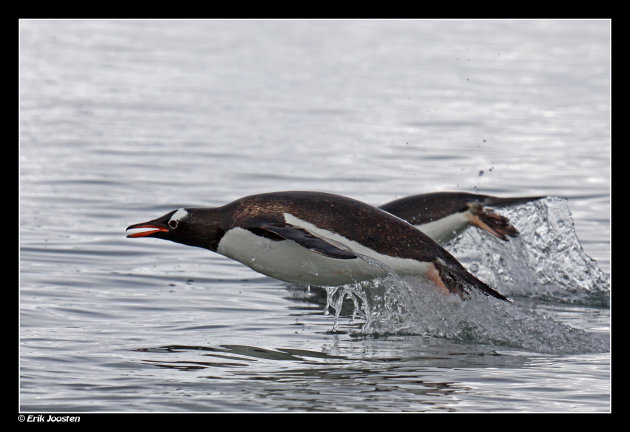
[255,223,358,259]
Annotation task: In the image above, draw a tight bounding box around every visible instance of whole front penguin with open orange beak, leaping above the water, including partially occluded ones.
[127,191,509,301]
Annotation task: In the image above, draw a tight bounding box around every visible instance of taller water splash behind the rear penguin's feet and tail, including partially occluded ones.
[446,197,610,307]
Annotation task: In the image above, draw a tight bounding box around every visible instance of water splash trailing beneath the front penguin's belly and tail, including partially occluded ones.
[327,274,610,354]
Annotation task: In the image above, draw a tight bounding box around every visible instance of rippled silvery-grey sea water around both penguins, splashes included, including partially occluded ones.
[19,20,611,412]
